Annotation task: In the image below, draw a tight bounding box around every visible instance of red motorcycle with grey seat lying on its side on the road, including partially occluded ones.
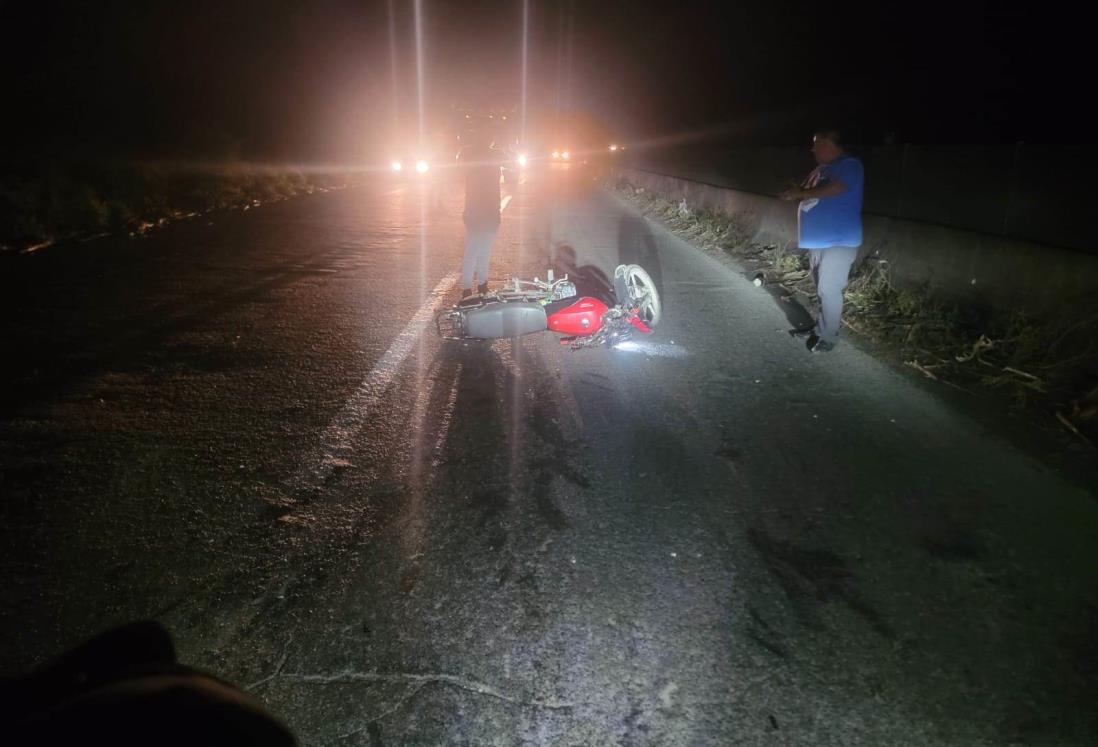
[435,265,662,349]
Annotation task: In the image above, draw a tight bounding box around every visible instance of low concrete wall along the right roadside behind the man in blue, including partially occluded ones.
[621,168,1098,316]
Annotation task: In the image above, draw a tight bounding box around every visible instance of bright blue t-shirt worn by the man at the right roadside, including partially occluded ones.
[797,156,865,249]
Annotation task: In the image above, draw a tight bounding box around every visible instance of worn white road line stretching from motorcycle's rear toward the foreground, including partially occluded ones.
[292,272,458,489]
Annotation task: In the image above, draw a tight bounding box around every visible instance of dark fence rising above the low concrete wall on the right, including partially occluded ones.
[627,144,1098,254]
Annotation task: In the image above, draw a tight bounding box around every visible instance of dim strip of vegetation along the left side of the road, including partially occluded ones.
[0,164,360,252]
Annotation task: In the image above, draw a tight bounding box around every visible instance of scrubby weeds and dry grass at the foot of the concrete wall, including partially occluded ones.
[612,180,1098,445]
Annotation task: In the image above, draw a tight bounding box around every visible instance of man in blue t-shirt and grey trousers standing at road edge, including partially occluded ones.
[782,130,865,353]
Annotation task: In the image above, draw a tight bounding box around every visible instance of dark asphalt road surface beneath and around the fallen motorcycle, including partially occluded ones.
[0,165,1098,746]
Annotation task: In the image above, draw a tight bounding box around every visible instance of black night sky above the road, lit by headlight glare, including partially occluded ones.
[0,0,1093,158]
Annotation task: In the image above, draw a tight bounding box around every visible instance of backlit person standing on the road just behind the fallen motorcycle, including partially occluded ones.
[458,127,502,298]
